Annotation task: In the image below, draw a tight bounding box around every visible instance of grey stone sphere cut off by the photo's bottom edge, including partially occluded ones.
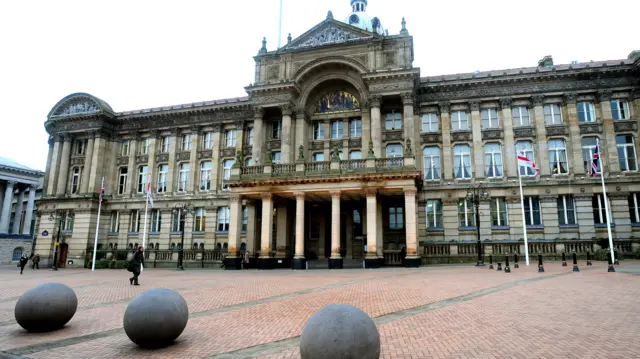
[300,304,380,359]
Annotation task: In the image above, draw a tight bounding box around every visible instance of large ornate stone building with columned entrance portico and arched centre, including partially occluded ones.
[37,0,640,268]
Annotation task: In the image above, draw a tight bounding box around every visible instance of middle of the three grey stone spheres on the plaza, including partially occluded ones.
[124,288,189,348]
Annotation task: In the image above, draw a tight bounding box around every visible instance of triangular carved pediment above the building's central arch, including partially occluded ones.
[280,19,379,51]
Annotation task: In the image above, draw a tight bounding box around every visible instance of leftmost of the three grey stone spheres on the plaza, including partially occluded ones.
[14,283,78,332]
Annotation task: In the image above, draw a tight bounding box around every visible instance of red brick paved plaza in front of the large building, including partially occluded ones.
[0,260,640,359]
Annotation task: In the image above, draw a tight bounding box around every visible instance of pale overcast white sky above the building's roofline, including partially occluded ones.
[0,0,640,170]
